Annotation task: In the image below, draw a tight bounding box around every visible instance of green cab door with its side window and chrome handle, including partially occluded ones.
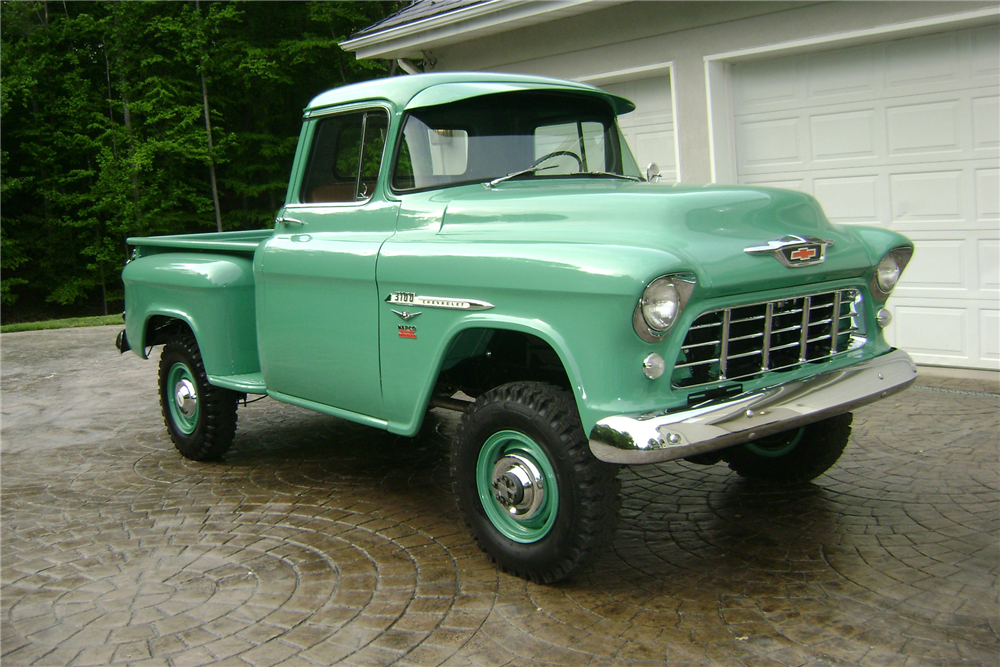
[255,108,398,423]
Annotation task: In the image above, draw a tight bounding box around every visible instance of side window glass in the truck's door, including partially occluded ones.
[300,109,389,204]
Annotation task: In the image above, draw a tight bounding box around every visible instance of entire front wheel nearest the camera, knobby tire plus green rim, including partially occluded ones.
[451,382,618,583]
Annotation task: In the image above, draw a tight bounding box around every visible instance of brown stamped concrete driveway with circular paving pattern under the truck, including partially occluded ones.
[0,327,1000,667]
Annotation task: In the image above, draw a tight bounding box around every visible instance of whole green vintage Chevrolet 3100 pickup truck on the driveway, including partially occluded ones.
[118,73,916,582]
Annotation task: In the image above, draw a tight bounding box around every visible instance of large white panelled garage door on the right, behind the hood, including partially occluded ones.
[732,25,1000,369]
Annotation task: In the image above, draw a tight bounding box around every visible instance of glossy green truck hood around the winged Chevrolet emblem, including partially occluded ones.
[434,180,878,296]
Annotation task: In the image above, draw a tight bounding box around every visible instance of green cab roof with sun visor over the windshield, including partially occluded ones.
[305,72,635,116]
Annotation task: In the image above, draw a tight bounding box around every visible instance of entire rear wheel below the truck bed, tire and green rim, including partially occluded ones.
[159,331,240,461]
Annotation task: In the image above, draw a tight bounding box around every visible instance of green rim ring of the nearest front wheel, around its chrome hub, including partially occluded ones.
[476,431,559,544]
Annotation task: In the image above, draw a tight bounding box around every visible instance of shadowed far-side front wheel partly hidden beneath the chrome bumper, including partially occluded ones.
[722,412,854,484]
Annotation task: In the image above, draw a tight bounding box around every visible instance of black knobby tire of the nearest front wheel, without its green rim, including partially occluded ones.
[451,382,620,583]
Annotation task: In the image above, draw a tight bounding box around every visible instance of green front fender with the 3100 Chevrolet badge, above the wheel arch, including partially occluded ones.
[378,233,691,435]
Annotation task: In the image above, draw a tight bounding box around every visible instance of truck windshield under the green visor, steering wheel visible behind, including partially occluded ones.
[392,91,639,191]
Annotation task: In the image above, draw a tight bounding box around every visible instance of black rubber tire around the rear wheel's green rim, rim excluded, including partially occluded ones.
[159,331,241,461]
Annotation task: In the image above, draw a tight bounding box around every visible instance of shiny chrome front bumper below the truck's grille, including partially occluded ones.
[590,350,917,464]
